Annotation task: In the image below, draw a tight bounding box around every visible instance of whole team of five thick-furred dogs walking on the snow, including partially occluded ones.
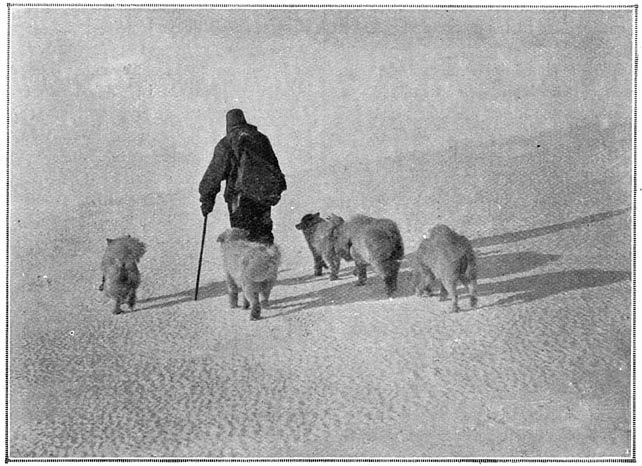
[99,213,477,320]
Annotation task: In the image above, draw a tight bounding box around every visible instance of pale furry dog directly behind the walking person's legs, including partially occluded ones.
[217,228,281,320]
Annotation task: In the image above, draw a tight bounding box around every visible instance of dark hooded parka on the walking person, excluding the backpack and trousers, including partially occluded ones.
[198,110,287,211]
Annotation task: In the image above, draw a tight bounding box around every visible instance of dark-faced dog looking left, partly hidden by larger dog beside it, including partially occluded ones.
[295,212,344,280]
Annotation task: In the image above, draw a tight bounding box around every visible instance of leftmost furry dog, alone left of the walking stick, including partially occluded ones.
[99,235,147,314]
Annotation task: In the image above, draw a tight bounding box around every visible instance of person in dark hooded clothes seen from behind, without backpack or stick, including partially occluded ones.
[198,109,287,244]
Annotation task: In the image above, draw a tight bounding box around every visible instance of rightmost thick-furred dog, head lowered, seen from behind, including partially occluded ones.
[414,224,477,312]
